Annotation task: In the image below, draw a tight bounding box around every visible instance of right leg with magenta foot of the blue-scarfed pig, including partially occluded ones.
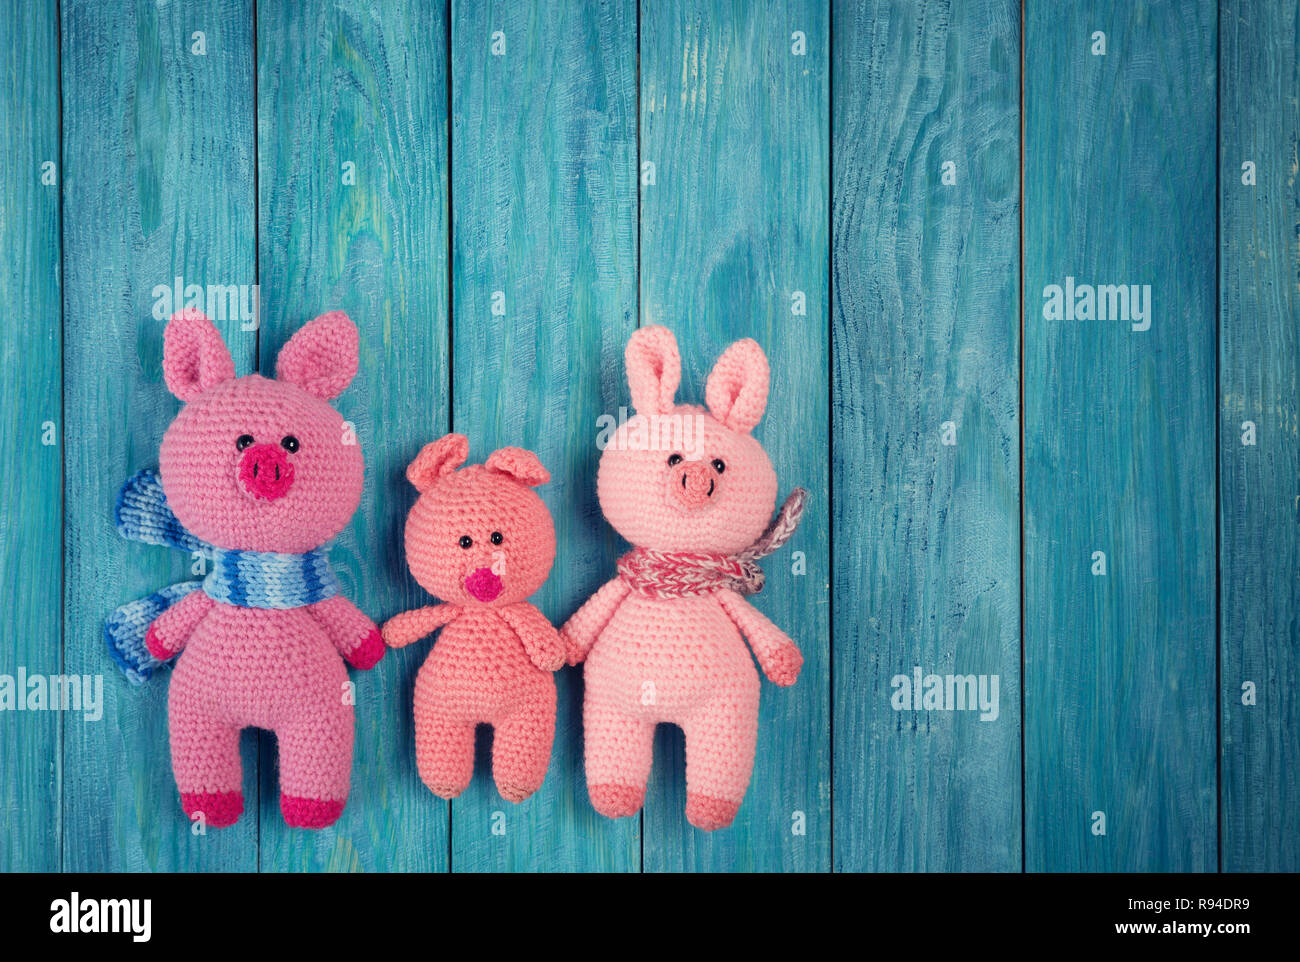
[276,699,354,828]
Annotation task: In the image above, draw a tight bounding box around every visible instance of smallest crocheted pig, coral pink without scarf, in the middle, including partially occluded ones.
[384,434,564,802]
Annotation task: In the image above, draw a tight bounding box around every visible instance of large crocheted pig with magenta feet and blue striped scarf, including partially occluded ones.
[107,311,385,828]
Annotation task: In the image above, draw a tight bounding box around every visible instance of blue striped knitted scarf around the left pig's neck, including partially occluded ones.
[104,471,338,684]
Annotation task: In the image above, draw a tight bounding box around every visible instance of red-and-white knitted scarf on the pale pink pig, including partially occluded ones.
[619,488,809,598]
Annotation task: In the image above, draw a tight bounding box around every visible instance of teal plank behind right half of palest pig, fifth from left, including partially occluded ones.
[641,0,831,871]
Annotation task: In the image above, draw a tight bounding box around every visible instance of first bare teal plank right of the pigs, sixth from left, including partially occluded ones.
[832,0,1021,871]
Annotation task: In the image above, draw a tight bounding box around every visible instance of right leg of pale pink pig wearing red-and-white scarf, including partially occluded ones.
[681,692,758,832]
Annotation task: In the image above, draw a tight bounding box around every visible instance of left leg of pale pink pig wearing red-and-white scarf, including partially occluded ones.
[582,689,654,819]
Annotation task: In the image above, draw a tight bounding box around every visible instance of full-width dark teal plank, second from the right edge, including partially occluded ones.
[1023,0,1217,871]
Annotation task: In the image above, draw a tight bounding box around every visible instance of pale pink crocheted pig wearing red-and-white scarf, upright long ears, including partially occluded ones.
[560,328,806,829]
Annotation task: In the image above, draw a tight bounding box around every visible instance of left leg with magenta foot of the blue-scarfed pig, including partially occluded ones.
[168,681,243,828]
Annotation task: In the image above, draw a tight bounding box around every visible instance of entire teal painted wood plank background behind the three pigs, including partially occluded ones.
[0,0,1300,871]
